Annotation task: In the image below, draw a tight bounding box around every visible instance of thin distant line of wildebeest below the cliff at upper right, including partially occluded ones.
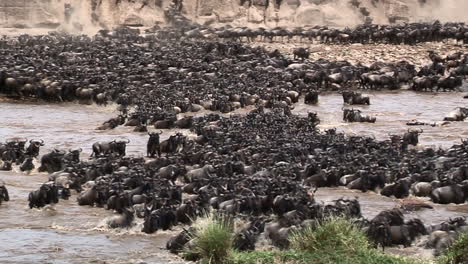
[217,21,468,45]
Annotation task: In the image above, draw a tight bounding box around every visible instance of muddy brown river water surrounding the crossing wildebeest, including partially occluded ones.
[0,92,468,263]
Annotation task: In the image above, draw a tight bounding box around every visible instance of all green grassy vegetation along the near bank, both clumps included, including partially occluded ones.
[183,214,421,264]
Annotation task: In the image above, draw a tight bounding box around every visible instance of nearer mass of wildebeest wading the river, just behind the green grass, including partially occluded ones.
[1,107,468,252]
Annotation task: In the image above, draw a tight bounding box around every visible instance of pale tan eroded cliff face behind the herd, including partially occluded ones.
[0,0,468,33]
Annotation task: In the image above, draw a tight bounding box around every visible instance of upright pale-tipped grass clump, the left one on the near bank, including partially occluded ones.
[183,213,234,264]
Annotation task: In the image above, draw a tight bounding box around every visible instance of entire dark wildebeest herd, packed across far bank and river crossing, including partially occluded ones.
[0,18,468,260]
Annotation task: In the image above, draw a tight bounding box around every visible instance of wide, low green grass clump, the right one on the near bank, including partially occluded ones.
[289,217,370,254]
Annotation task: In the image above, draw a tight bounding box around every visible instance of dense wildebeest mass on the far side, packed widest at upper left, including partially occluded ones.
[0,28,468,131]
